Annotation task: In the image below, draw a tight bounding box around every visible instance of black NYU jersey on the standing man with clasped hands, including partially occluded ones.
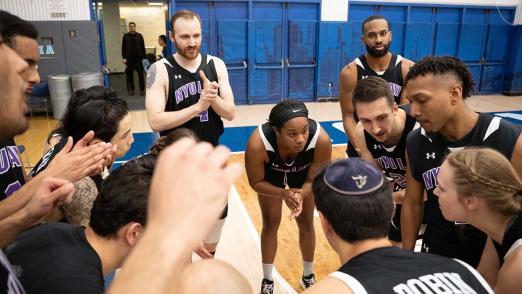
[160,54,224,146]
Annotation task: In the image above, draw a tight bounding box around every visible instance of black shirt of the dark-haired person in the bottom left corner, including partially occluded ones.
[5,223,104,294]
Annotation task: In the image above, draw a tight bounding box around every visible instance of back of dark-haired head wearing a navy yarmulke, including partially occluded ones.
[312,158,394,243]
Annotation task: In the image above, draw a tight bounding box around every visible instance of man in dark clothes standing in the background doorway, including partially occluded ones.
[121,22,145,95]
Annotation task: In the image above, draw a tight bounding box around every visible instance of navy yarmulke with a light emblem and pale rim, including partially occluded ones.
[324,158,384,195]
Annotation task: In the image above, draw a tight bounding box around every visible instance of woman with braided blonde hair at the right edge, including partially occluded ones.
[434,148,522,294]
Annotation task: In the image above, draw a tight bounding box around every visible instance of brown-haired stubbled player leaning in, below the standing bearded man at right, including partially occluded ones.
[352,77,415,247]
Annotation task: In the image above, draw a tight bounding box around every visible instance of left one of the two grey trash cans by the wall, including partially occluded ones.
[47,75,72,119]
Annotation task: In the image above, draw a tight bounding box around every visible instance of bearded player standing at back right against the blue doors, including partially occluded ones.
[339,15,413,157]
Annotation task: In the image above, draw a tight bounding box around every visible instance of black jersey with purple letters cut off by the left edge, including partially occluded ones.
[0,138,25,201]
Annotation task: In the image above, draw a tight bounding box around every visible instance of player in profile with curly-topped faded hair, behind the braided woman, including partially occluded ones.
[401,57,522,266]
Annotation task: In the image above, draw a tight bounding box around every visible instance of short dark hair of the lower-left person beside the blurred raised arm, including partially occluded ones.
[89,156,156,238]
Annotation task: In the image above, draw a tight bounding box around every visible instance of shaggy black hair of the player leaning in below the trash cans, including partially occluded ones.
[61,86,129,142]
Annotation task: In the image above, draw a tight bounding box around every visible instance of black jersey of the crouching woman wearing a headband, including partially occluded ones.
[258,119,321,188]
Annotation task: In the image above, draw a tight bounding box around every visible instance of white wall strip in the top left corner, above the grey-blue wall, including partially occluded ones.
[0,0,91,21]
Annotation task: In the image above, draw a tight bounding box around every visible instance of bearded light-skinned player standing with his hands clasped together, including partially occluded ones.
[145,10,235,253]
